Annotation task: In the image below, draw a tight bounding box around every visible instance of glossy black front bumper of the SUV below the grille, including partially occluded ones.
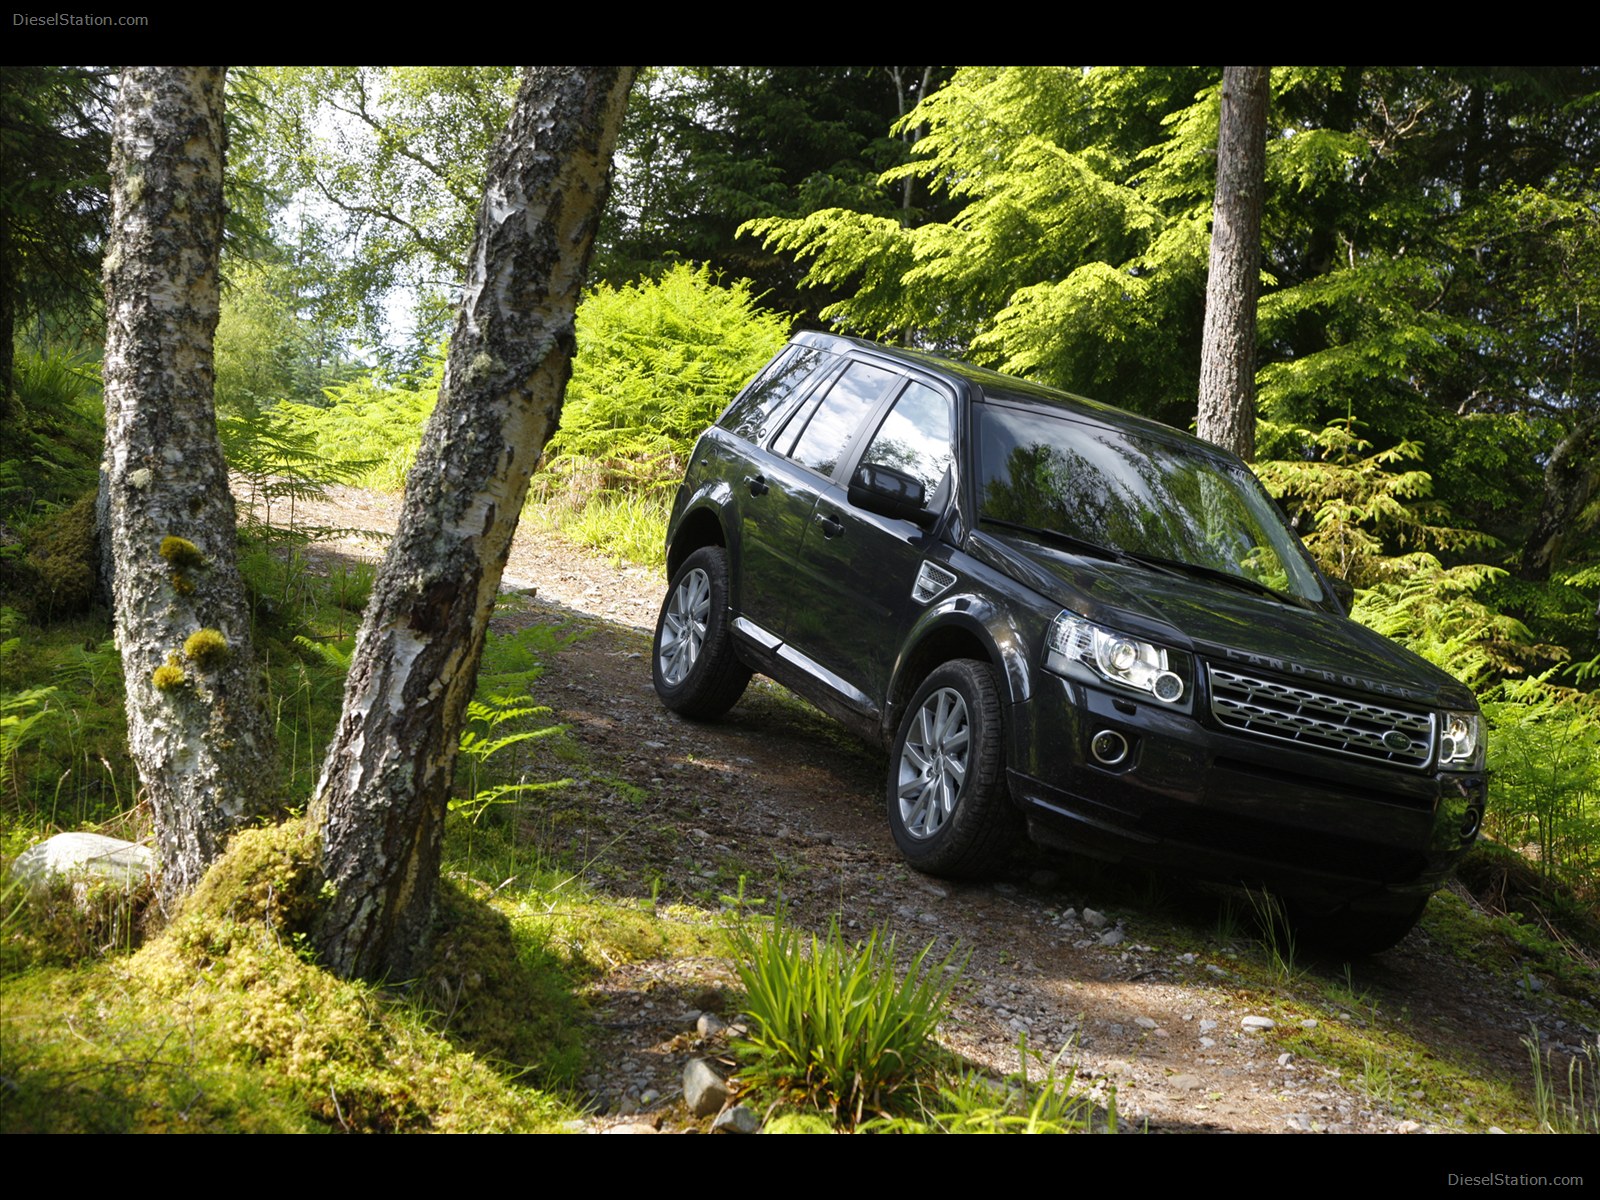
[1008,672,1488,906]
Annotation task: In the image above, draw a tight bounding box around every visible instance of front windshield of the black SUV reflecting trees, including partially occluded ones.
[976,405,1323,600]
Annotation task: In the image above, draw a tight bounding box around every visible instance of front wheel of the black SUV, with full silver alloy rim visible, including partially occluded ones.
[888,659,1021,878]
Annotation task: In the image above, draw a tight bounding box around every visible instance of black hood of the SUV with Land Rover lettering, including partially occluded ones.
[968,531,1477,709]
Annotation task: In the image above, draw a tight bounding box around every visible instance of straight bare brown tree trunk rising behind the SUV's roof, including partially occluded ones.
[1197,67,1269,462]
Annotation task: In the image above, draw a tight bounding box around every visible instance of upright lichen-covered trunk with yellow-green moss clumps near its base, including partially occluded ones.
[102,67,272,898]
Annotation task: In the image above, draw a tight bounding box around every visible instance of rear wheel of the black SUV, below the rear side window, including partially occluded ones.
[650,546,750,720]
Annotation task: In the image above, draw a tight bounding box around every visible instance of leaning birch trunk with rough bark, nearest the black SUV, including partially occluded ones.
[312,67,634,981]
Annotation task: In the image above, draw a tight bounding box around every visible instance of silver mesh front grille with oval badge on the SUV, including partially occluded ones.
[1208,666,1434,766]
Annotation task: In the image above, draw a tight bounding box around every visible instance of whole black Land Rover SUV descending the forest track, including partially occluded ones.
[651,333,1486,952]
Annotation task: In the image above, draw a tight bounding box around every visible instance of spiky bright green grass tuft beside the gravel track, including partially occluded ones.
[731,917,960,1125]
